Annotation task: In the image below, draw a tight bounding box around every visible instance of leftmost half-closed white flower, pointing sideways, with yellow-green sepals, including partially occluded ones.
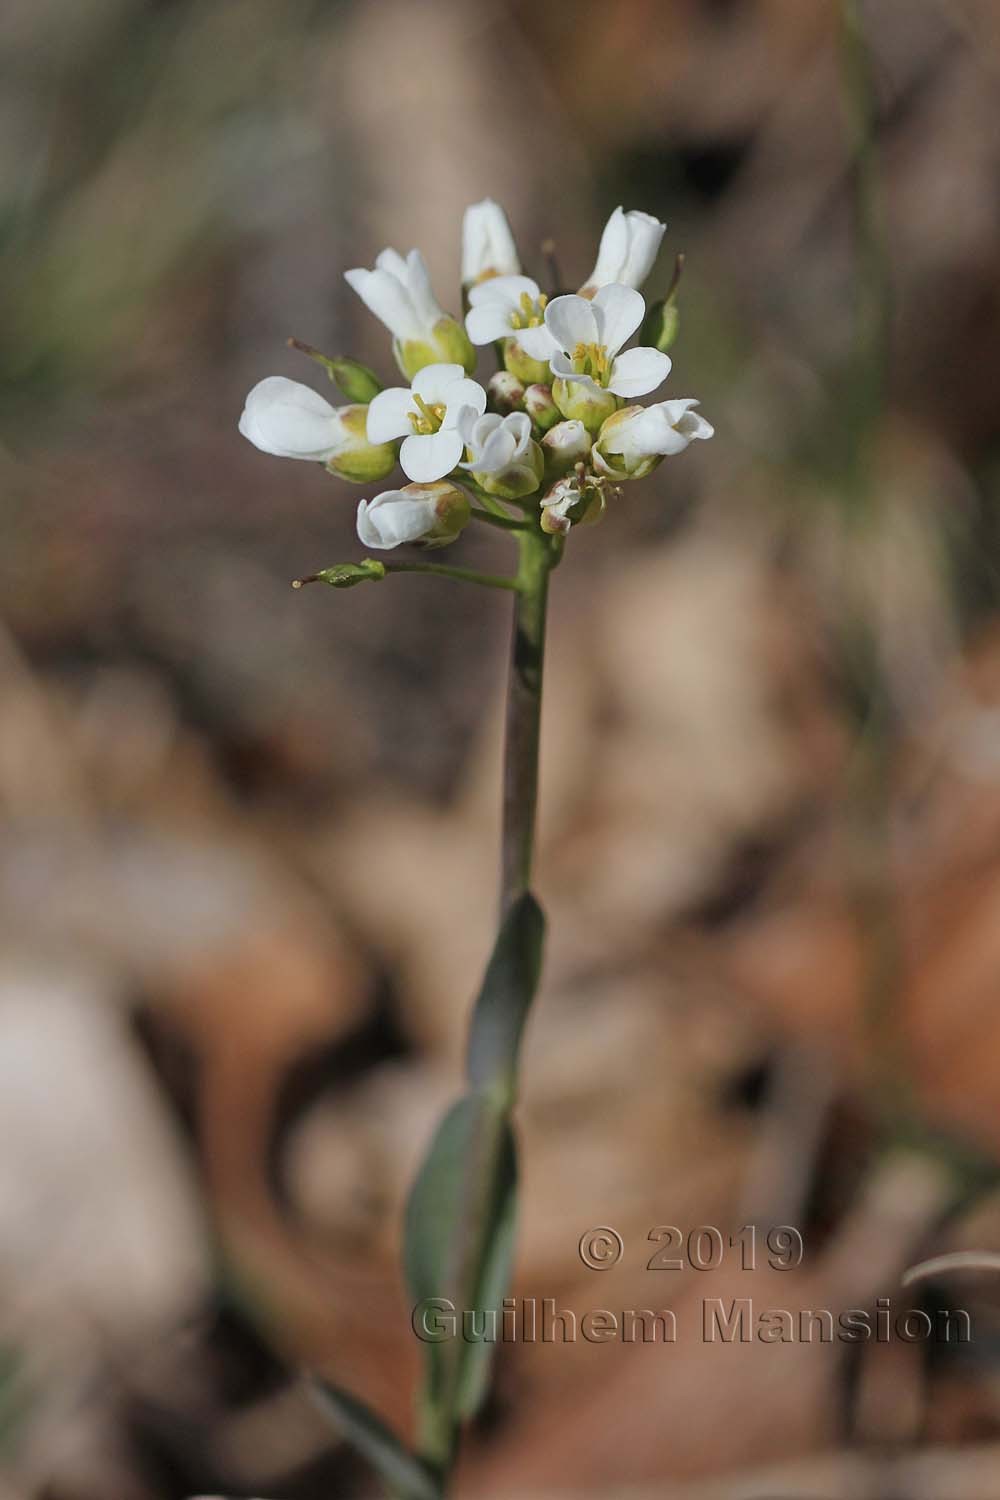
[240,375,396,482]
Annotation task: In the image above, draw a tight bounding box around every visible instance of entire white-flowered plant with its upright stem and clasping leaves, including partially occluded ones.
[240,200,712,1500]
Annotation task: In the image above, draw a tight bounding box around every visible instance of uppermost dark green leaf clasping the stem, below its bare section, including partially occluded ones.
[466,893,546,1097]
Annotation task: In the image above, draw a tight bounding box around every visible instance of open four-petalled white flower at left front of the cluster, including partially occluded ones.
[367,365,486,483]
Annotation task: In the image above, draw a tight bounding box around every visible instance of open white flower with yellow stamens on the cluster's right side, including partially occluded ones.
[546,285,670,399]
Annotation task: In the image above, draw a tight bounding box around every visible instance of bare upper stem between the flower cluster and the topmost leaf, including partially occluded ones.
[501,527,558,920]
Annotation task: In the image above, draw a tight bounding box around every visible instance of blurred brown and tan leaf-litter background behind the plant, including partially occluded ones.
[0,0,1000,1500]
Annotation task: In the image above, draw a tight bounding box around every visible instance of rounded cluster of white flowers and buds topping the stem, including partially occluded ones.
[240,200,712,549]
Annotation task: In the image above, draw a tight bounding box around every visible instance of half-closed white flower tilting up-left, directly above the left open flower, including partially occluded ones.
[343,251,475,380]
